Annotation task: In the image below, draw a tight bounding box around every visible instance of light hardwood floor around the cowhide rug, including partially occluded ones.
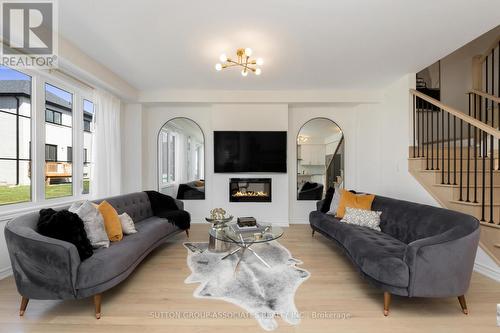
[0,225,500,333]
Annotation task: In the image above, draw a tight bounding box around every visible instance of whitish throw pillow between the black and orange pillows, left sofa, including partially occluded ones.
[68,201,109,249]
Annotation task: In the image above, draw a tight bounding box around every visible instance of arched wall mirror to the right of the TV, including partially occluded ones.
[297,118,344,200]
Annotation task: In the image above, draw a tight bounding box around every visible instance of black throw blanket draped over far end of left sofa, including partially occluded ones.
[144,191,191,230]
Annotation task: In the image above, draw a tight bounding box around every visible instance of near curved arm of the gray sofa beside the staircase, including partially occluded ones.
[404,228,480,297]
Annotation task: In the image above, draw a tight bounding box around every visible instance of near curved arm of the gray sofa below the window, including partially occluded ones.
[5,217,80,299]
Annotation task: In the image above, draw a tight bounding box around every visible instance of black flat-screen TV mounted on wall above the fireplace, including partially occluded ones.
[214,131,286,173]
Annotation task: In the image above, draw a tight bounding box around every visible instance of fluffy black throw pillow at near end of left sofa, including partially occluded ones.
[37,208,94,261]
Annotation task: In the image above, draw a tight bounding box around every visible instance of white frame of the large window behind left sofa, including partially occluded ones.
[0,66,98,217]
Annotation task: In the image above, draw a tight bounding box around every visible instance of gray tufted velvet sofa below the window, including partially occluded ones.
[5,192,187,319]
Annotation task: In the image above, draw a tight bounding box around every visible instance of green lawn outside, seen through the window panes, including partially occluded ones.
[0,180,90,205]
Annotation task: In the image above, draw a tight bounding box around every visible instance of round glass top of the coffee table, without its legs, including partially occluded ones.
[210,222,283,244]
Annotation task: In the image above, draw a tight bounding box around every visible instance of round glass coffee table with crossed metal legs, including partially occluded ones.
[210,223,283,272]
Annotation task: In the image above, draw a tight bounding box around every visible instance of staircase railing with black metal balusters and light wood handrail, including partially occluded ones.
[410,88,500,225]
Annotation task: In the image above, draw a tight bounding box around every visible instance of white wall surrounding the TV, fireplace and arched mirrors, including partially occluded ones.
[131,74,437,225]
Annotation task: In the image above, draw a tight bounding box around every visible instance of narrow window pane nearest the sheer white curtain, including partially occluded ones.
[82,99,95,194]
